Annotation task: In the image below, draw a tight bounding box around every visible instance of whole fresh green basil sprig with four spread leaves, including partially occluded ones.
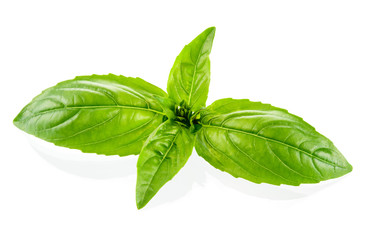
[14,27,352,209]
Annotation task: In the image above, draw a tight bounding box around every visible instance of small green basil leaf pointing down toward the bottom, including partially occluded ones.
[136,121,195,209]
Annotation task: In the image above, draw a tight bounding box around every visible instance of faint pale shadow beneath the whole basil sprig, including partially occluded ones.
[28,136,338,208]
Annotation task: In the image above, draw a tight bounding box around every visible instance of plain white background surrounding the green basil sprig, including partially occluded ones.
[0,0,365,240]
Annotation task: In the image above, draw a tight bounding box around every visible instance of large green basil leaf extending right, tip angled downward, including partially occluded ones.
[196,99,352,185]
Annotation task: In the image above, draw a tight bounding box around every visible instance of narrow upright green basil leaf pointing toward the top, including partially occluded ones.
[167,27,215,111]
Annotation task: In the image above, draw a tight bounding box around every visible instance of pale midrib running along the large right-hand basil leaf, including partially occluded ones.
[202,124,344,168]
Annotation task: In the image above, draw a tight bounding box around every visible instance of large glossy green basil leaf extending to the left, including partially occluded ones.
[14,74,167,156]
